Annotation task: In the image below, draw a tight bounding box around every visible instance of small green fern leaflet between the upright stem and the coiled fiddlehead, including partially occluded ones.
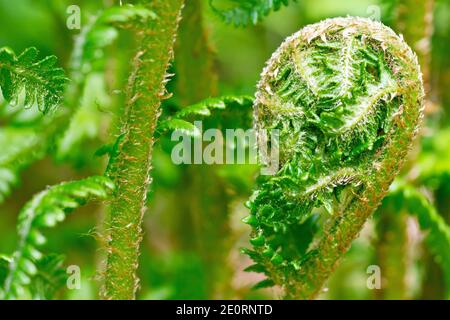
[157,96,253,136]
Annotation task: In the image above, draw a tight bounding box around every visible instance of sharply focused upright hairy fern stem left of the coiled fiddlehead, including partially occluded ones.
[101,0,183,299]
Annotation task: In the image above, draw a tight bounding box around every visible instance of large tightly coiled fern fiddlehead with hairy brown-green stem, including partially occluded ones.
[245,17,424,298]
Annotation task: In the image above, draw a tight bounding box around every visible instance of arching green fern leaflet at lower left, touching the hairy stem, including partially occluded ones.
[4,176,113,298]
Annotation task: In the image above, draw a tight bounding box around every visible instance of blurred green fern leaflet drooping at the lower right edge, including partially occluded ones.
[383,183,450,299]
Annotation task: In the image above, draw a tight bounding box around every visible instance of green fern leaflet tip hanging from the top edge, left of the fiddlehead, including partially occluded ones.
[209,0,296,26]
